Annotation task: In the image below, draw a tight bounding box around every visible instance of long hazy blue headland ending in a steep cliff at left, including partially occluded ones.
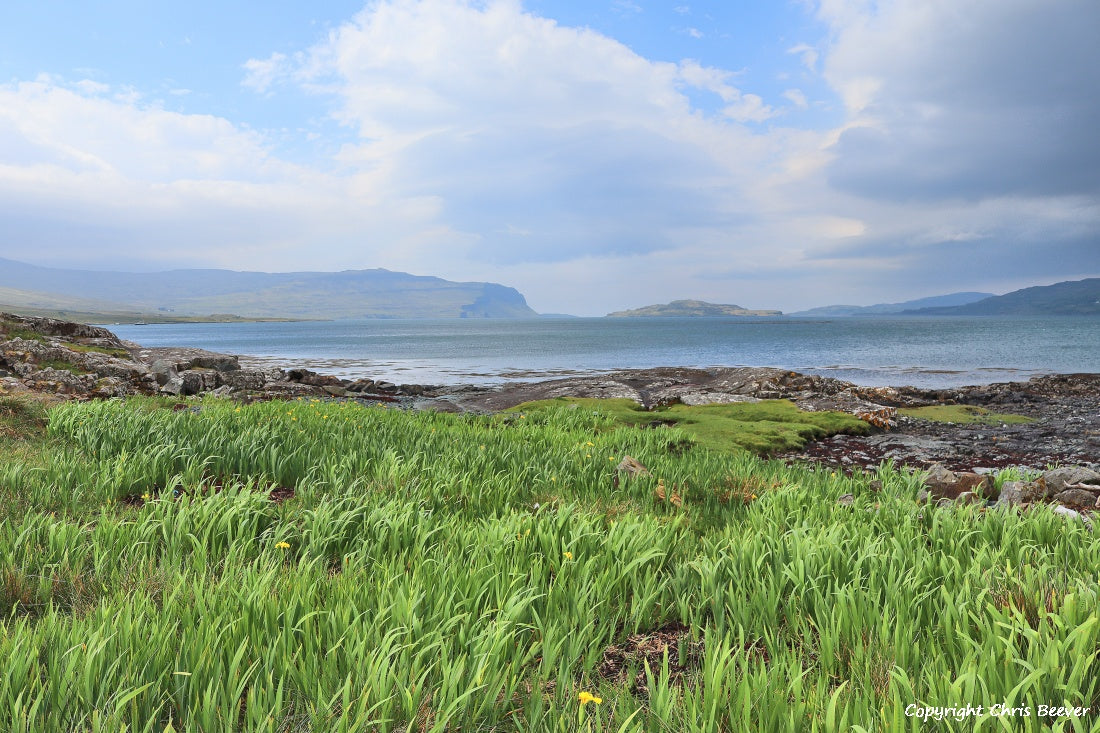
[0,259,538,319]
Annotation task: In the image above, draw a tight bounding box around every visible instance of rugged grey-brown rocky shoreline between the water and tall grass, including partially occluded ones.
[0,305,1100,473]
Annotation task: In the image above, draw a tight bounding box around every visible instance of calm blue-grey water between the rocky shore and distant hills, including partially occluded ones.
[108,317,1100,387]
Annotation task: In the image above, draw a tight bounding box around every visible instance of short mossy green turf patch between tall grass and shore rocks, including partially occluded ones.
[508,397,869,456]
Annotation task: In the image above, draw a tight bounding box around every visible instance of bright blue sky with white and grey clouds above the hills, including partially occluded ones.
[0,0,1100,316]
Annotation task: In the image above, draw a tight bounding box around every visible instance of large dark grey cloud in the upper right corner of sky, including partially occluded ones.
[828,0,1100,200]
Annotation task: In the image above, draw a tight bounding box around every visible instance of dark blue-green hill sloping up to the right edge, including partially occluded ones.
[905,277,1100,316]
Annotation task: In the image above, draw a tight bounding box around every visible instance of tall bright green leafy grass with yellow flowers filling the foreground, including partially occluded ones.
[0,396,1100,733]
